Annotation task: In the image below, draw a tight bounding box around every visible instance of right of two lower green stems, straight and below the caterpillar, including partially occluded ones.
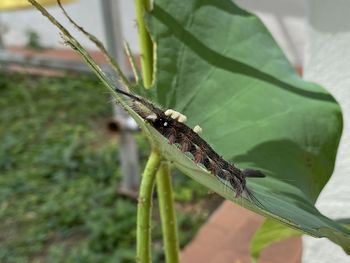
[156,162,179,263]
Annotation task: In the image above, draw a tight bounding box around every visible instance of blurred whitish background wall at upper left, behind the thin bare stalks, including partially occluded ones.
[0,0,138,50]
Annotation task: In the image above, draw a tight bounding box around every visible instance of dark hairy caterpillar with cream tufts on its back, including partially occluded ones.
[115,88,265,205]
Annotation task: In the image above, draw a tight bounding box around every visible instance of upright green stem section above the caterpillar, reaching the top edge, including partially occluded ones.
[136,0,153,89]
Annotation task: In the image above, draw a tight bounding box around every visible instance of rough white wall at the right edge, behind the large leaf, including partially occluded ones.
[303,0,350,263]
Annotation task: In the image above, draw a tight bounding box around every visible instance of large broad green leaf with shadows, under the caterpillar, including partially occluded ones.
[140,0,350,251]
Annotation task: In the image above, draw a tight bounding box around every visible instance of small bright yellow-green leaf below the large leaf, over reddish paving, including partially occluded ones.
[250,219,302,262]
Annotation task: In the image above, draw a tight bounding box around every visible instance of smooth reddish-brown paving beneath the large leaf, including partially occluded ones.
[181,201,302,263]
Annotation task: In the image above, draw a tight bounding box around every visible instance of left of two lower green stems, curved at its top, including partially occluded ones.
[136,150,161,263]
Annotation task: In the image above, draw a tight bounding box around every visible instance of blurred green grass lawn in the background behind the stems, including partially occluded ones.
[0,72,220,263]
